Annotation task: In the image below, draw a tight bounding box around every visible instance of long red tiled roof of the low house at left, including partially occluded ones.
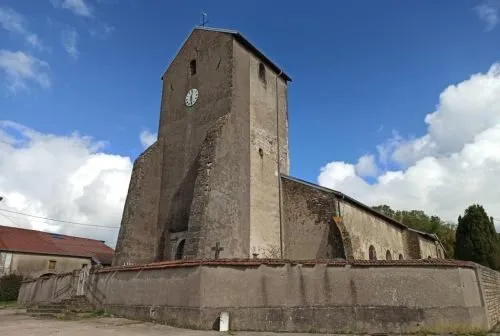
[0,226,114,264]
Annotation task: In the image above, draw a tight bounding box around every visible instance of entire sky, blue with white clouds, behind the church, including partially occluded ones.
[0,0,500,239]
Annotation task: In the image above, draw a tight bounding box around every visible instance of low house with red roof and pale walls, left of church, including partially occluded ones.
[0,226,114,278]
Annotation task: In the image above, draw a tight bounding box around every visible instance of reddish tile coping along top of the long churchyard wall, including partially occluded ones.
[99,259,477,272]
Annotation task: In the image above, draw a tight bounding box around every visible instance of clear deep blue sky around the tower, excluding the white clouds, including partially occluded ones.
[0,0,500,181]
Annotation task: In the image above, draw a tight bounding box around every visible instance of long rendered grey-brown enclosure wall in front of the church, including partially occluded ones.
[15,259,499,333]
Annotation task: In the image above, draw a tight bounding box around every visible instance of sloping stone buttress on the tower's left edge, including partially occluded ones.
[113,140,163,265]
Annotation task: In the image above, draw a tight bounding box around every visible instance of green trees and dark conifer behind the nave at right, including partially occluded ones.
[373,204,500,270]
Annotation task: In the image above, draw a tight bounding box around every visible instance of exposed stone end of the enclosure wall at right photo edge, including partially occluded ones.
[478,266,500,325]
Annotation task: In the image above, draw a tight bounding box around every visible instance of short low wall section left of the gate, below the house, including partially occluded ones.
[17,272,78,306]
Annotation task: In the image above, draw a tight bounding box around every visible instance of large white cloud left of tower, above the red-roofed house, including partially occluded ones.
[0,121,132,246]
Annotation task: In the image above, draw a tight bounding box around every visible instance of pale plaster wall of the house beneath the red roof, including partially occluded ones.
[10,253,91,278]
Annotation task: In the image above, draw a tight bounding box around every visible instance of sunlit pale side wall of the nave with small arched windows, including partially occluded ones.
[340,201,407,260]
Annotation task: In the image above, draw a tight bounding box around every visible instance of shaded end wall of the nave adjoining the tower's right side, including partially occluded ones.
[281,177,350,260]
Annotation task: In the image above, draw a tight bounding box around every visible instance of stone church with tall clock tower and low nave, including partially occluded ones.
[113,27,445,266]
